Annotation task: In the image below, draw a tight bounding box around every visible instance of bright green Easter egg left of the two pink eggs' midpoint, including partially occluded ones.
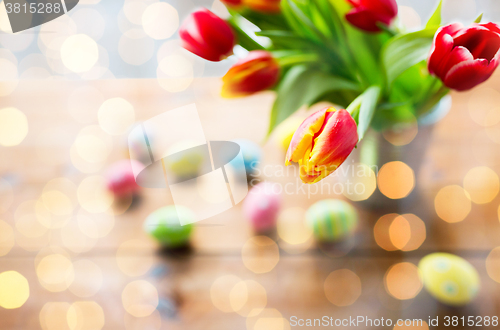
[144,205,195,248]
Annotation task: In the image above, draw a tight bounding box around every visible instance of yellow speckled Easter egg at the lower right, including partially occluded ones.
[418,253,480,306]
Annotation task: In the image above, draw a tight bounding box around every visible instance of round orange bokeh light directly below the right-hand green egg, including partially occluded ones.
[324,269,361,306]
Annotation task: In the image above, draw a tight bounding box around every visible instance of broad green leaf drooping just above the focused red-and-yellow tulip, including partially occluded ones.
[268,65,359,134]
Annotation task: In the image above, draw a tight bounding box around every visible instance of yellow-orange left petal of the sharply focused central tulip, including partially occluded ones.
[286,108,335,165]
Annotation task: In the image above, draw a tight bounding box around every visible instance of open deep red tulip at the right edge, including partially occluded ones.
[428,23,500,91]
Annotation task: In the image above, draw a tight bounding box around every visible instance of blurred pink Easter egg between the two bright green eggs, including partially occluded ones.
[243,182,281,232]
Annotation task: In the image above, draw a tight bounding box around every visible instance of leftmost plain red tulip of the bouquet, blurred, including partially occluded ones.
[179,9,235,62]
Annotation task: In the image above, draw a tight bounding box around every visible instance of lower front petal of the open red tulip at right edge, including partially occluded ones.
[443,59,498,91]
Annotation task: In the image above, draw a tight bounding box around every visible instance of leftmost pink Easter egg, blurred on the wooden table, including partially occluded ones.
[105,159,144,197]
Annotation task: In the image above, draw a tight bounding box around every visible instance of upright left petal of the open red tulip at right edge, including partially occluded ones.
[428,23,463,74]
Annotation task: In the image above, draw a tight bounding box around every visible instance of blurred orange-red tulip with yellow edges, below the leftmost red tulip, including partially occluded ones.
[222,50,280,98]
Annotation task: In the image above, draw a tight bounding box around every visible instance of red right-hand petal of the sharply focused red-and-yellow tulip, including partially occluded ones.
[310,109,358,167]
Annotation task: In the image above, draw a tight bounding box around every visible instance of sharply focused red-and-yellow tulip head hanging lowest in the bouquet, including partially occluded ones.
[286,107,358,183]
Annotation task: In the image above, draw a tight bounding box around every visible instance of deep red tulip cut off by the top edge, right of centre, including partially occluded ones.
[345,0,398,32]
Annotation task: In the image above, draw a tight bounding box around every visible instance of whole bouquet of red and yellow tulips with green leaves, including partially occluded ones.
[179,0,500,183]
